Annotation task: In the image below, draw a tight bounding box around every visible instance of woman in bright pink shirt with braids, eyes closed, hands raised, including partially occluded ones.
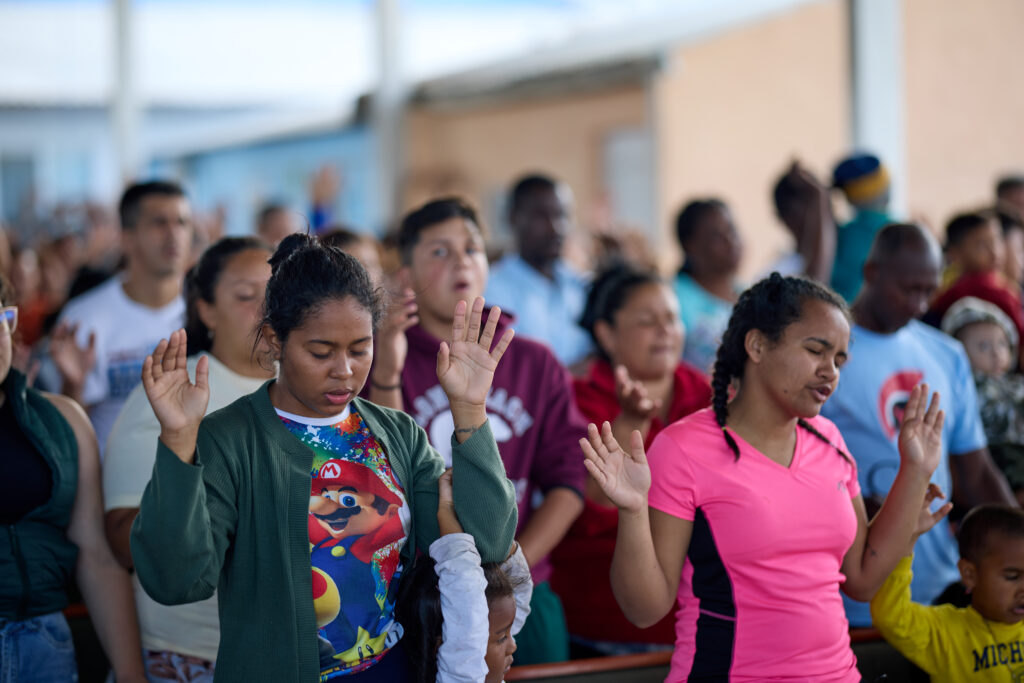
[582,273,949,683]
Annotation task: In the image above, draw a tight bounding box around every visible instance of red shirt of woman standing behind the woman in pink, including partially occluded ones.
[551,359,711,645]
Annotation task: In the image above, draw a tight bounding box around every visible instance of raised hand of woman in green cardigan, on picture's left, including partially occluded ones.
[142,330,210,463]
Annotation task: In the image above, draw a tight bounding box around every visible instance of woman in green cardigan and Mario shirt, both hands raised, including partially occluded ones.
[131,234,516,683]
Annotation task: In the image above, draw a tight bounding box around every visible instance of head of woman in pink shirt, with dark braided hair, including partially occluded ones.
[712,272,850,458]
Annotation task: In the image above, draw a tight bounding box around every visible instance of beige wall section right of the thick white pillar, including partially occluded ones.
[903,0,1024,230]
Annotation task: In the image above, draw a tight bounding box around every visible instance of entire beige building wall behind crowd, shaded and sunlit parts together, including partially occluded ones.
[403,0,1024,280]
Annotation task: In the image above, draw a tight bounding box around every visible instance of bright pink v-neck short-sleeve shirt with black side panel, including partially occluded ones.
[647,409,860,683]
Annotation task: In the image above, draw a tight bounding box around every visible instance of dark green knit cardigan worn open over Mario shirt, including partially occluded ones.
[131,380,517,683]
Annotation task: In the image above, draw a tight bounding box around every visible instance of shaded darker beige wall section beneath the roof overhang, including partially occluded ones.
[402,85,647,254]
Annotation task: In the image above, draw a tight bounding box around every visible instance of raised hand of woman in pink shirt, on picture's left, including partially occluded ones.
[580,422,650,512]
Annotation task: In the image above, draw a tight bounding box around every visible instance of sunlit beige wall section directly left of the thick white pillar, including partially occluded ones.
[654,0,850,281]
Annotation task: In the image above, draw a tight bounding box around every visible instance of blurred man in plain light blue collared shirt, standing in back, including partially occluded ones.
[484,175,592,366]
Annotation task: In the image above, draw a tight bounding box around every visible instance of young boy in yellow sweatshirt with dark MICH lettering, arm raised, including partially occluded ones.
[871,505,1024,683]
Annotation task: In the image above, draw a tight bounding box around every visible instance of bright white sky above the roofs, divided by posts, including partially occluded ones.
[0,0,737,108]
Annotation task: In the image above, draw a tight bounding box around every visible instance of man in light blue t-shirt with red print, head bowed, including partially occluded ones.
[821,224,1016,627]
